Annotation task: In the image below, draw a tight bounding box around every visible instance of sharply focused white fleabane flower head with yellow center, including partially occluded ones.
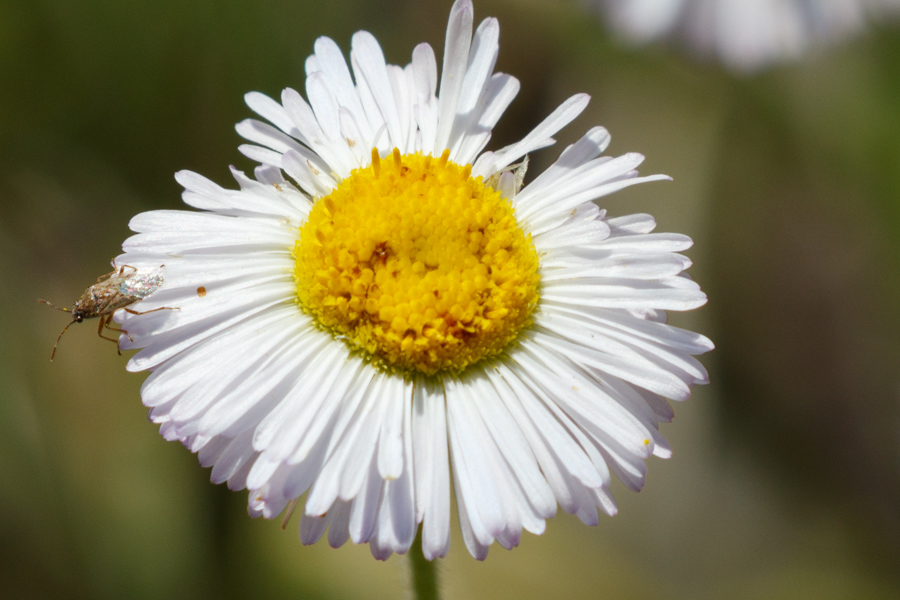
[117,0,712,559]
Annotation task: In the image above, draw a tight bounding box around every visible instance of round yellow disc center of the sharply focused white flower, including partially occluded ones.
[294,149,540,375]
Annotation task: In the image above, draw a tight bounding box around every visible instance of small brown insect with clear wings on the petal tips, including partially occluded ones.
[38,263,179,360]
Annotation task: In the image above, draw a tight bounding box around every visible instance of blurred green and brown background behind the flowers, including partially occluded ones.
[0,0,900,600]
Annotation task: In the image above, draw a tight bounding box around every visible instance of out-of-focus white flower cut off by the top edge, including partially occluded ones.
[593,0,900,72]
